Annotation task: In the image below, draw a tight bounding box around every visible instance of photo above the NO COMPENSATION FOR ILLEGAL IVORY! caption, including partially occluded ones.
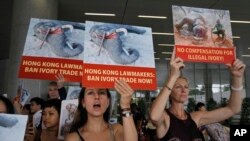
[172,6,234,47]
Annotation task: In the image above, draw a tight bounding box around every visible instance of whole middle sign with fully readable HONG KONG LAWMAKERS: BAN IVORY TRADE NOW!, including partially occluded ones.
[82,21,157,90]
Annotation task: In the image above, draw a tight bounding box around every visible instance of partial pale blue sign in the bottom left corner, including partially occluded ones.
[0,113,28,141]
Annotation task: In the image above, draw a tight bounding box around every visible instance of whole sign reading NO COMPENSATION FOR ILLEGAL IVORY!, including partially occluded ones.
[172,6,236,63]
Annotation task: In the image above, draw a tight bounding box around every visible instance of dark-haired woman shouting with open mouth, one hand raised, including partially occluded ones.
[65,80,138,141]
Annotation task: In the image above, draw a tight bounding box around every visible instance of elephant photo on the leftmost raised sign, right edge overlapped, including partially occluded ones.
[23,18,85,60]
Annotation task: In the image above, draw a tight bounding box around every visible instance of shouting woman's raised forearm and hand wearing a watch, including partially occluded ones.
[114,80,138,141]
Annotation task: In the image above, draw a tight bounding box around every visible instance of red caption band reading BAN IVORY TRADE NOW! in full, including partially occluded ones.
[82,64,157,90]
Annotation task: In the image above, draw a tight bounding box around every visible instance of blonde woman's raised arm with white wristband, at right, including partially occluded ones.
[196,59,246,125]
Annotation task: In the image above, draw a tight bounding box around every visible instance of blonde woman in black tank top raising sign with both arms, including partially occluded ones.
[150,49,245,141]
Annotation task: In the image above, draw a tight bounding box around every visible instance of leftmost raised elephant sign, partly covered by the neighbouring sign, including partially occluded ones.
[19,18,85,82]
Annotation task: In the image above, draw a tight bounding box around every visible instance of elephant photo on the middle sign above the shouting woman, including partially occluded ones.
[84,21,155,67]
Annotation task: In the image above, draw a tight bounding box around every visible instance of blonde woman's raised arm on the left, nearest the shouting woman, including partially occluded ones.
[150,49,185,126]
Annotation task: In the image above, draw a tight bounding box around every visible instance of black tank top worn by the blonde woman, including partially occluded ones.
[161,109,205,141]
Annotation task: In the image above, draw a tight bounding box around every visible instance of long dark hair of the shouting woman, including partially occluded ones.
[70,87,111,132]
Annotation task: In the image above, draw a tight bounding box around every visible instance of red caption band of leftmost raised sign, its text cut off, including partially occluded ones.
[19,56,83,82]
